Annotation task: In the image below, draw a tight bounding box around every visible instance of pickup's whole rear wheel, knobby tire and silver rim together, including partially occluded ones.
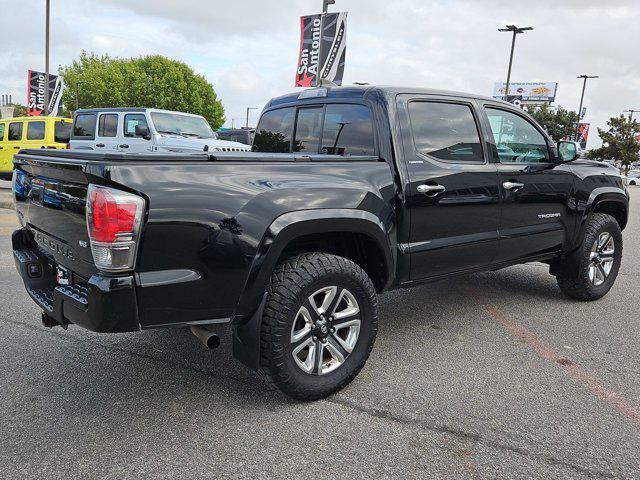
[260,253,378,400]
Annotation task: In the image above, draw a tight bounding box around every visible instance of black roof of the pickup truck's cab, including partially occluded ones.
[265,85,506,108]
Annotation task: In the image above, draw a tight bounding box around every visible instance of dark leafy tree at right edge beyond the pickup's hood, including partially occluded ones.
[588,115,640,173]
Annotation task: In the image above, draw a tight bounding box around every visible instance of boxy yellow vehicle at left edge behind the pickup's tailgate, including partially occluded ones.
[0,117,73,179]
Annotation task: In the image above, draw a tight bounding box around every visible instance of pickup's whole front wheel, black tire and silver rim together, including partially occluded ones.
[556,213,622,300]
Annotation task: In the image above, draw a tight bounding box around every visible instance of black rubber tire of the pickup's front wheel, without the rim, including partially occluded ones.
[556,213,622,301]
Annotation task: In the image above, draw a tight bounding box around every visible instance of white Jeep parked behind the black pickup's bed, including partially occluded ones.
[70,108,251,153]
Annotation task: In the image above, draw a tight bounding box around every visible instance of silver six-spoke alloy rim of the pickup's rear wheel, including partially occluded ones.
[290,286,361,375]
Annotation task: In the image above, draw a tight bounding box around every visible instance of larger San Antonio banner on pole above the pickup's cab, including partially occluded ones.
[295,12,347,87]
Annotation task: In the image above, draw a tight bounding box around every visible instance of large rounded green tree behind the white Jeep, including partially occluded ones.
[59,52,224,130]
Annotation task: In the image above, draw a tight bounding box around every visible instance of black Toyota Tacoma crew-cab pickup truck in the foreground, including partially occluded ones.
[13,86,628,400]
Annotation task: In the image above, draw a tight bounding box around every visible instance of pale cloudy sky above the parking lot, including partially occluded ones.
[0,0,640,147]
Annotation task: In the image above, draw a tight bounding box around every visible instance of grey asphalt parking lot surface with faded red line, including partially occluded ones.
[0,190,640,479]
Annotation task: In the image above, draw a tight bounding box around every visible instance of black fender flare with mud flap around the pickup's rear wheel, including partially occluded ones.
[232,209,397,370]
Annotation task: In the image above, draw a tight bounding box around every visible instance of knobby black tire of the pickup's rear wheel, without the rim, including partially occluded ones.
[260,252,378,401]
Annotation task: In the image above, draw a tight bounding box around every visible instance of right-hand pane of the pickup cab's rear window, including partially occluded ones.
[321,104,375,155]
